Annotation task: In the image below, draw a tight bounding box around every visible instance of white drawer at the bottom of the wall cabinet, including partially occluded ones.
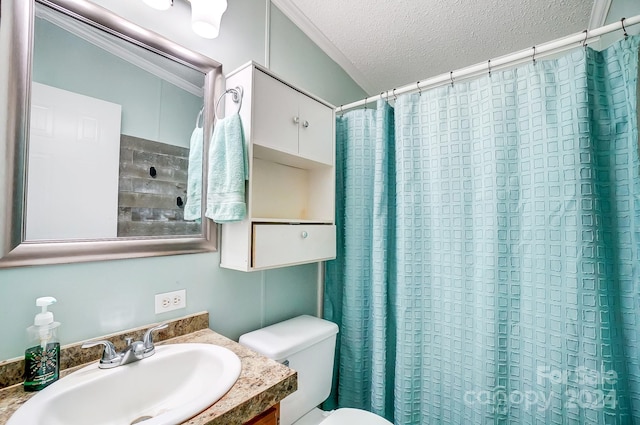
[252,224,336,269]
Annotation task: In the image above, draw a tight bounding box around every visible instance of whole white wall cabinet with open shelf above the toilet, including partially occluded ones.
[220,62,336,271]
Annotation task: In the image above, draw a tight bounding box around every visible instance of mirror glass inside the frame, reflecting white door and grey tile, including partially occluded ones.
[25,4,204,241]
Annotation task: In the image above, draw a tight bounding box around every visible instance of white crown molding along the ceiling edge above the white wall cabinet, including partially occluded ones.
[271,0,375,94]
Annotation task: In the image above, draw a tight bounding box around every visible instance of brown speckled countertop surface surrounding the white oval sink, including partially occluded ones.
[0,329,298,425]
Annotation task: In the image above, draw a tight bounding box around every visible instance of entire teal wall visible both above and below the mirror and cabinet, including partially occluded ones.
[0,0,364,361]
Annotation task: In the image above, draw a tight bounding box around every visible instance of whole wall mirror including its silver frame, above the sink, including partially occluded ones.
[0,0,223,267]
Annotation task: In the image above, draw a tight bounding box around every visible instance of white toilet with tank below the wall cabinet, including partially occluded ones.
[240,316,392,425]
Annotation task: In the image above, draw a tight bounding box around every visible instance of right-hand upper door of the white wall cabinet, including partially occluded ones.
[298,94,334,165]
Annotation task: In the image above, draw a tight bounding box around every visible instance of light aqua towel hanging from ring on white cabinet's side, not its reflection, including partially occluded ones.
[204,113,249,223]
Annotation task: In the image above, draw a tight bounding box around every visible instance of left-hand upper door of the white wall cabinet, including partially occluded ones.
[252,70,300,155]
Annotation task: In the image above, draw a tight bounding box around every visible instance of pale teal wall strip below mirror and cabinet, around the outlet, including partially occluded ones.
[0,253,317,359]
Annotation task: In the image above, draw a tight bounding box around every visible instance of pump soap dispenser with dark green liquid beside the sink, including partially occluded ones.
[24,297,60,391]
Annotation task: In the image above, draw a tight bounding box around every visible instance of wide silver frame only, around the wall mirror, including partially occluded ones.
[0,0,224,269]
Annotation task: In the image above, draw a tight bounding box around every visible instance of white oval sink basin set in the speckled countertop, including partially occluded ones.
[7,344,241,425]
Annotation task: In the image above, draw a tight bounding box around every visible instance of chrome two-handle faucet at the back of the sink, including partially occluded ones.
[82,323,168,369]
